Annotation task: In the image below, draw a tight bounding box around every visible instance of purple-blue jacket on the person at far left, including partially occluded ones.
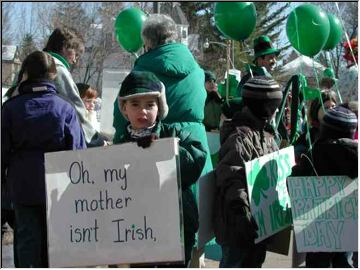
[1,81,86,205]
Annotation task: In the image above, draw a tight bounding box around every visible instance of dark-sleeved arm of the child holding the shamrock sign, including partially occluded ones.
[215,132,258,239]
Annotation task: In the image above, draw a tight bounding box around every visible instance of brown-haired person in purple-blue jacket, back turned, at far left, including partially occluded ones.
[1,51,86,268]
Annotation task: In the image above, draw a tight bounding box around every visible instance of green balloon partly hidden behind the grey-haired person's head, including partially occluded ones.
[115,8,146,52]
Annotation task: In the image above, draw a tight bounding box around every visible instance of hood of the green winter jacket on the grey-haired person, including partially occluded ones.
[135,43,198,78]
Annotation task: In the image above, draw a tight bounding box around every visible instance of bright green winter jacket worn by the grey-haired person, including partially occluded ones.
[113,43,212,175]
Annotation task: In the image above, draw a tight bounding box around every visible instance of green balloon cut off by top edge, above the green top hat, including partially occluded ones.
[215,2,256,41]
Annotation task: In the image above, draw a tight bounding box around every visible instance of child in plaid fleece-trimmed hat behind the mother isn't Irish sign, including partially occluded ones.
[117,71,207,267]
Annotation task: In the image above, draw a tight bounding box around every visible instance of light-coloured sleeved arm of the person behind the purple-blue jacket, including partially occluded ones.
[55,64,105,147]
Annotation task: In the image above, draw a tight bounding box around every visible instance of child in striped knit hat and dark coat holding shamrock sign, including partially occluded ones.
[213,76,282,268]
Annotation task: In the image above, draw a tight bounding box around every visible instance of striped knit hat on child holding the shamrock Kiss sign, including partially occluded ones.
[242,76,282,119]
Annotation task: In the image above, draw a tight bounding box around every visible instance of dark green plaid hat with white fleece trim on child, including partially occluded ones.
[118,71,169,119]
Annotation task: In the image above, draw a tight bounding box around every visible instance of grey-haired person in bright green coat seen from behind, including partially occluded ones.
[113,14,213,267]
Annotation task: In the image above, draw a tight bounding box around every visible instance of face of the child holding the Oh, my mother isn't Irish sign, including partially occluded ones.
[124,96,159,129]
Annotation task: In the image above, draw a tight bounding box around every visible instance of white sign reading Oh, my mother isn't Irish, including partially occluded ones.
[45,138,184,267]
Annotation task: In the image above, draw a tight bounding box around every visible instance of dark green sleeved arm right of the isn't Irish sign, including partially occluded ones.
[178,132,207,188]
